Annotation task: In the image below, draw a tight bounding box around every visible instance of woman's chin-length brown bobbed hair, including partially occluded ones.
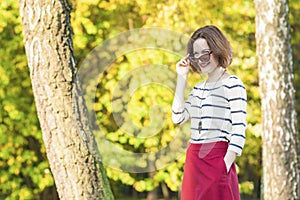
[187,25,233,71]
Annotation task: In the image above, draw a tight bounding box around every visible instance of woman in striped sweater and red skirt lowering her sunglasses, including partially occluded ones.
[172,26,246,200]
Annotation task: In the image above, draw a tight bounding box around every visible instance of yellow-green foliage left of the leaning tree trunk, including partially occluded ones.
[0,0,53,199]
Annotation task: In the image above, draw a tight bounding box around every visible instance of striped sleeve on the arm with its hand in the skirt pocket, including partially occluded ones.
[227,76,247,156]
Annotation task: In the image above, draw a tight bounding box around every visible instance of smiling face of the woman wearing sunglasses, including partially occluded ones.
[193,38,218,74]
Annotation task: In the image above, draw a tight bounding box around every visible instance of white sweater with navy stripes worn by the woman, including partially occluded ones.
[172,76,247,156]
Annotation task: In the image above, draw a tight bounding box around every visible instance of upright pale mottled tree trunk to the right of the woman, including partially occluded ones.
[255,0,299,200]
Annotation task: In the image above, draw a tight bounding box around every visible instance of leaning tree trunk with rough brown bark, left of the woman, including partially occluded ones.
[20,0,113,200]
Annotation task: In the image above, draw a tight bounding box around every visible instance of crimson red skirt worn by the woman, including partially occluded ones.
[181,142,240,200]
